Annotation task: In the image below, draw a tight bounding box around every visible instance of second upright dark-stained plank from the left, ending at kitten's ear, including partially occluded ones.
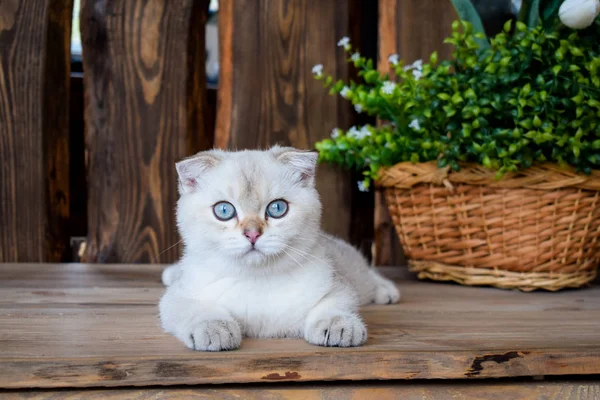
[81,0,212,263]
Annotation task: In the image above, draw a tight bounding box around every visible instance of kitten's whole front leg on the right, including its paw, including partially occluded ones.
[304,291,367,347]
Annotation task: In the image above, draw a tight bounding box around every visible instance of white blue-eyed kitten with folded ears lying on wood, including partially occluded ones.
[159,147,400,351]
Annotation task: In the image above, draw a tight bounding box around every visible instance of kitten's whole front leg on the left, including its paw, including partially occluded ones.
[159,290,242,351]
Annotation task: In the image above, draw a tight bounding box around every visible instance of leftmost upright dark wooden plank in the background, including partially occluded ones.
[0,0,73,262]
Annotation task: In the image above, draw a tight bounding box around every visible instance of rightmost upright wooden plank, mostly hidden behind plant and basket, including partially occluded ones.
[374,0,457,265]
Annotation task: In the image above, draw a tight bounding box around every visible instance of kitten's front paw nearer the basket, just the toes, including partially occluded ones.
[305,315,367,347]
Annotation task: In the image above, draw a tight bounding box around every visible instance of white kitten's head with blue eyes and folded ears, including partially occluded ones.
[177,147,321,266]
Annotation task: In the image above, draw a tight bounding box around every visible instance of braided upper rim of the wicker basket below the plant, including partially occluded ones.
[375,161,600,191]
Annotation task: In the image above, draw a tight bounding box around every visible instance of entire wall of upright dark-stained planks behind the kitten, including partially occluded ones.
[0,0,454,264]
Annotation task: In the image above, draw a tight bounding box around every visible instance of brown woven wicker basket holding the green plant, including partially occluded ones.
[377,162,600,291]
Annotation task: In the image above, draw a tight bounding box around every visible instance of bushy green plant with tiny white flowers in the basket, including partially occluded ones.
[313,2,600,190]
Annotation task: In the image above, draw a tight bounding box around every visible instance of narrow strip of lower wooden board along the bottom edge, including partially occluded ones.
[0,381,600,400]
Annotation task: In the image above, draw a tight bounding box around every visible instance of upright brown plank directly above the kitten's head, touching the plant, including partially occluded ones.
[215,0,355,238]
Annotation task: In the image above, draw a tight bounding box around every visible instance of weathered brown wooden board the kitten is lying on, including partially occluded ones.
[0,264,600,388]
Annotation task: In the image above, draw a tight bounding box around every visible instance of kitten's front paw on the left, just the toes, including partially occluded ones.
[186,320,242,351]
